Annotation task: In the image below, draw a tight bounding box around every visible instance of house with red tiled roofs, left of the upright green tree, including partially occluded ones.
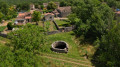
[14,12,32,25]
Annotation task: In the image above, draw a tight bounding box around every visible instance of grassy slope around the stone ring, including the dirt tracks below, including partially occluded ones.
[41,32,91,67]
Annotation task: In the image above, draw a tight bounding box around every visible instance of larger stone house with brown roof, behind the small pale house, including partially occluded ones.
[53,6,71,17]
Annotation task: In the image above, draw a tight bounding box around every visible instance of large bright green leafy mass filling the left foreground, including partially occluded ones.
[0,24,45,67]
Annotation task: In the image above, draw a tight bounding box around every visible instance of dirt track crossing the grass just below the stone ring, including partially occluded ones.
[41,53,92,67]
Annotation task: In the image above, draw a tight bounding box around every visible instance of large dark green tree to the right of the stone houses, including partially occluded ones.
[73,0,114,43]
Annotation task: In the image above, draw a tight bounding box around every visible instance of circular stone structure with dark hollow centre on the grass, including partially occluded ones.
[51,41,68,53]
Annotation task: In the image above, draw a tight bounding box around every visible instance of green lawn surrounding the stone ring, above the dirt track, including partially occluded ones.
[41,32,80,58]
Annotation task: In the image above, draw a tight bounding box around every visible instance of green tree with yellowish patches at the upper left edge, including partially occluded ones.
[0,2,17,22]
